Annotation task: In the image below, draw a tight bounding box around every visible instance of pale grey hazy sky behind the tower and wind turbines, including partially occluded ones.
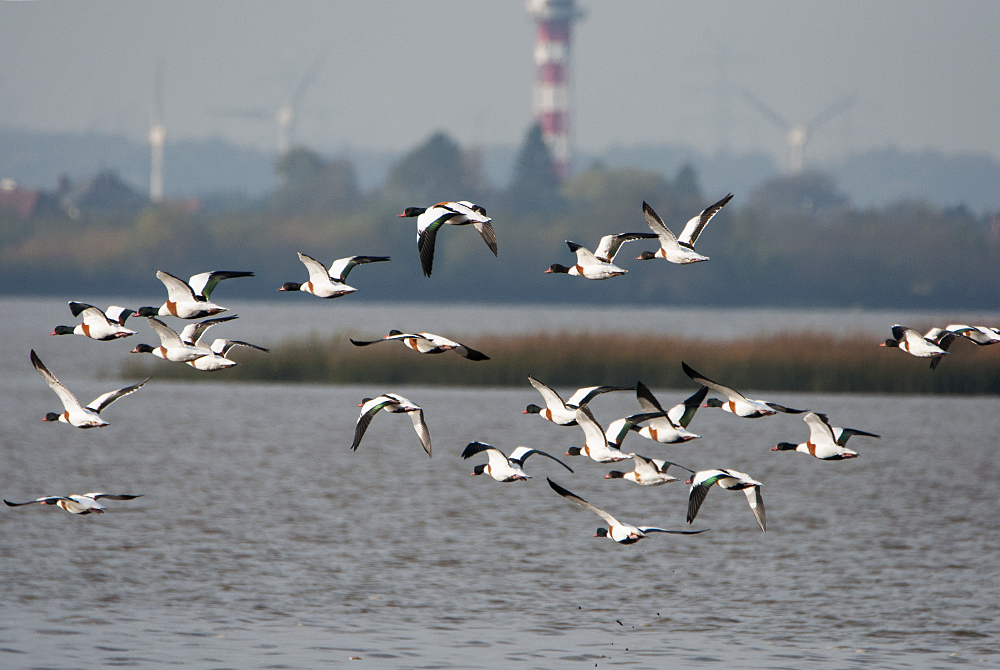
[0,0,1000,164]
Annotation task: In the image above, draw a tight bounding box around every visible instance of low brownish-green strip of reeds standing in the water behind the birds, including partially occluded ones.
[123,333,1000,394]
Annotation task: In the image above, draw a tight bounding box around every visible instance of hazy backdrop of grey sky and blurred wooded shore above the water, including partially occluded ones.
[0,0,1000,310]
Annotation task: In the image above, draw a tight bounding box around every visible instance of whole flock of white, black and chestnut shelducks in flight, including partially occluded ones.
[4,194,1000,544]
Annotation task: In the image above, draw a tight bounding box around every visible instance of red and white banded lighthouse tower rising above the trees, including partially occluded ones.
[527,0,583,178]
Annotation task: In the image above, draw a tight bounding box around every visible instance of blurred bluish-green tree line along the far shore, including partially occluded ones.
[0,127,1000,310]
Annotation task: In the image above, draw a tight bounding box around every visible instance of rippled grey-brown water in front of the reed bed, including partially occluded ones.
[0,301,1000,669]
